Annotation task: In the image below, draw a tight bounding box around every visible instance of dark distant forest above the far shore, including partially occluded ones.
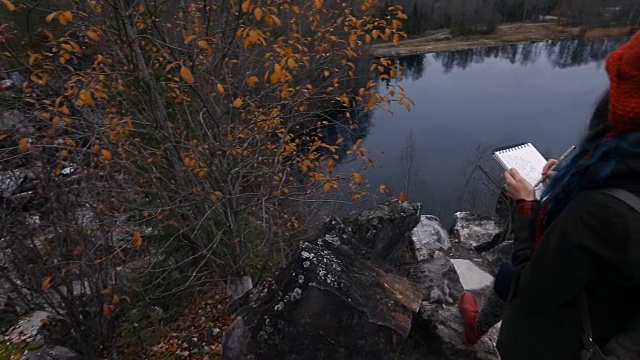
[384,0,640,35]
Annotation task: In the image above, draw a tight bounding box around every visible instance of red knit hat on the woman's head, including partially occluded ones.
[607,31,640,133]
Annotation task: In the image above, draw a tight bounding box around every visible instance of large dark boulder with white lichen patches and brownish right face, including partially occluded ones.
[222,212,421,360]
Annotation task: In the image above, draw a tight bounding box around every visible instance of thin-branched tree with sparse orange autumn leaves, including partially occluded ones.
[0,0,411,353]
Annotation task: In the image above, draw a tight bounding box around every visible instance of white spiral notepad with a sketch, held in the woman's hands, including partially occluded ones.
[493,143,547,185]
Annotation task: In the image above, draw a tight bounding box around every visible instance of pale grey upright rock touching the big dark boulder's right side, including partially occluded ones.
[411,215,451,260]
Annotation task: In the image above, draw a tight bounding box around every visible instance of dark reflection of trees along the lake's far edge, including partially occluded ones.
[397,39,626,76]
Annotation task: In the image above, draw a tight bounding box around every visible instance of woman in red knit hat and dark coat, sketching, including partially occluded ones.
[497,33,640,360]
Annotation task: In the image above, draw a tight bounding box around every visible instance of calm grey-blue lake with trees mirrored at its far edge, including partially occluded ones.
[342,39,625,225]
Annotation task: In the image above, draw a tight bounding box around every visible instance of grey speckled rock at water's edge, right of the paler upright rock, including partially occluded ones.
[451,212,502,249]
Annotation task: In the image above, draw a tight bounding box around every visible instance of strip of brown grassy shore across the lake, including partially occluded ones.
[369,23,632,57]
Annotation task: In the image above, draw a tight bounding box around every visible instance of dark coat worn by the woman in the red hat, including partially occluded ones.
[497,164,640,360]
